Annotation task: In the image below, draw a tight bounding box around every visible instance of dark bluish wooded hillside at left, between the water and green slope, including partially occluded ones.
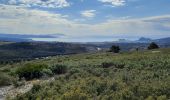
[0,42,87,62]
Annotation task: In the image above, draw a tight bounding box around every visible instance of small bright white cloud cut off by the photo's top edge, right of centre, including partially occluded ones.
[99,0,126,7]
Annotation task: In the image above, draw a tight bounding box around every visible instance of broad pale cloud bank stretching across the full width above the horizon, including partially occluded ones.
[0,5,170,41]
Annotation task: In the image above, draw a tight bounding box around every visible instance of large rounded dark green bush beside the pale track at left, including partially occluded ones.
[16,64,48,80]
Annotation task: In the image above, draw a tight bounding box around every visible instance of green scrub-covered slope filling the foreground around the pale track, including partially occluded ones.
[0,49,170,100]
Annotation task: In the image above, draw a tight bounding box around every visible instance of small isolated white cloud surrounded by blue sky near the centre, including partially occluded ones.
[81,10,96,18]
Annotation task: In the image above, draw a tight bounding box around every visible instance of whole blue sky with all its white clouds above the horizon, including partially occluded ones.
[0,0,170,42]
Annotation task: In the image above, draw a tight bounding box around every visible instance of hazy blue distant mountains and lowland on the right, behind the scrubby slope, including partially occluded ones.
[80,37,170,51]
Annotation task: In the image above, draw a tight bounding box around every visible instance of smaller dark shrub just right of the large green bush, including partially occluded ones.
[51,65,67,74]
